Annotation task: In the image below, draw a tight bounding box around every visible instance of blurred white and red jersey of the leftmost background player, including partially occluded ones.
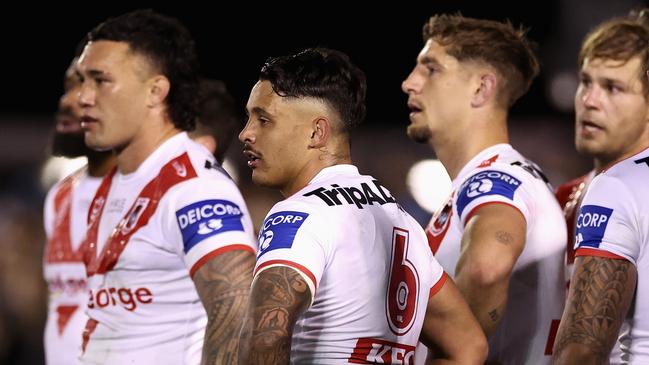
[43,167,101,365]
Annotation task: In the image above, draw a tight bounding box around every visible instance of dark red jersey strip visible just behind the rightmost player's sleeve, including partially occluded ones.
[554,170,595,288]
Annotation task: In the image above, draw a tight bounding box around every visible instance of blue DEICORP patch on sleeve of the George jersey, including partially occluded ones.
[176,199,243,252]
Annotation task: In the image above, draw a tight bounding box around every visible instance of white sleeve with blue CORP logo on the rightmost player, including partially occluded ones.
[575,175,642,264]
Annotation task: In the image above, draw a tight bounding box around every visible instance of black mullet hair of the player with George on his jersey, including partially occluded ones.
[88,9,198,131]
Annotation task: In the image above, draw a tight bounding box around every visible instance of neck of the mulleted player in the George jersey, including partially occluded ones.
[117,122,180,174]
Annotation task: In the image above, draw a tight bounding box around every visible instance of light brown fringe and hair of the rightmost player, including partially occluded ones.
[578,9,649,98]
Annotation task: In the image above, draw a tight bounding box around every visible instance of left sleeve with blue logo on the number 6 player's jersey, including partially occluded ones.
[255,201,331,304]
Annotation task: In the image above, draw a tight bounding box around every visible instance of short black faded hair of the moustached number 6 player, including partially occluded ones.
[259,47,367,133]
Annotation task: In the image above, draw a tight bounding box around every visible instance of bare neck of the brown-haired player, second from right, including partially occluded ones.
[429,111,509,180]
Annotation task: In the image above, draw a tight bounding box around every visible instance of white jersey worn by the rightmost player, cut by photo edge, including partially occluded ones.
[575,149,649,364]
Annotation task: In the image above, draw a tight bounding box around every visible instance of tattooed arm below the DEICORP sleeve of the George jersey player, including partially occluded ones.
[194,250,255,365]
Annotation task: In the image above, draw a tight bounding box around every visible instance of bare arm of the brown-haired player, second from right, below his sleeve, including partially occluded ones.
[455,204,526,337]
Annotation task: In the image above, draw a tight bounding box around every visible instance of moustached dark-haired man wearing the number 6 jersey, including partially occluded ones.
[239,48,486,364]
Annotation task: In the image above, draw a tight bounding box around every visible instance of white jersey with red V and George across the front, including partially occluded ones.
[82,133,256,364]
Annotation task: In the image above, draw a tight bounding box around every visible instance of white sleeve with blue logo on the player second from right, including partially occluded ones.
[456,164,534,226]
